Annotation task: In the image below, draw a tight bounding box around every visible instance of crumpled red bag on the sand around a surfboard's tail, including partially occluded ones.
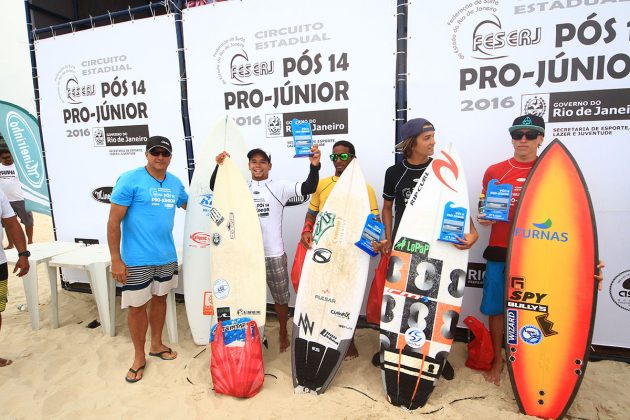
[210,320,265,398]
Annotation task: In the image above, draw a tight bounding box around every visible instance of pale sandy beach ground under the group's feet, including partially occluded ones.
[0,214,630,419]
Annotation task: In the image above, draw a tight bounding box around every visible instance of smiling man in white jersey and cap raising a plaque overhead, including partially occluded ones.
[210,145,321,353]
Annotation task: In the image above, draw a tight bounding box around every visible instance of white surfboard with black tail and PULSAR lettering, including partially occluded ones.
[291,159,370,394]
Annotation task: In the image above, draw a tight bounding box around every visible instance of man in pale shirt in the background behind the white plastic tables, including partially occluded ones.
[0,149,33,249]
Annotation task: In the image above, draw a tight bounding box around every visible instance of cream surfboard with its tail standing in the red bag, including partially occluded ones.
[209,158,267,337]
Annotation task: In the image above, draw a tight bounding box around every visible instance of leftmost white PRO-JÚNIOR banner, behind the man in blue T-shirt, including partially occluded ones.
[35,15,188,281]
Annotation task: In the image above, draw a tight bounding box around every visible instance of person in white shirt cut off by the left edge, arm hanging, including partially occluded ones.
[0,190,29,368]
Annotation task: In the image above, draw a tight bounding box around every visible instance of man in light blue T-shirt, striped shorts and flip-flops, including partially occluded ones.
[107,136,188,383]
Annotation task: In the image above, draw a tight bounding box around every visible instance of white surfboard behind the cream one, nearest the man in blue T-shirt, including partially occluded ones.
[182,117,249,345]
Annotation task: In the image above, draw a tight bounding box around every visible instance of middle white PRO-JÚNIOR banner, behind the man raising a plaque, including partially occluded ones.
[183,0,396,306]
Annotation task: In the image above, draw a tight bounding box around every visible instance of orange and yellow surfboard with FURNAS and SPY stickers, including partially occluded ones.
[505,139,598,418]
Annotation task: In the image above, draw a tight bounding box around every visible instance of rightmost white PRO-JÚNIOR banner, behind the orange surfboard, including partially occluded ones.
[408,0,630,347]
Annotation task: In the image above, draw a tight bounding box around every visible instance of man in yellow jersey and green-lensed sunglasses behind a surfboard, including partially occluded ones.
[301,140,379,360]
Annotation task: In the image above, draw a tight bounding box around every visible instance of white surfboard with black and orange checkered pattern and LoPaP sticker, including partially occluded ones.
[380,145,470,409]
